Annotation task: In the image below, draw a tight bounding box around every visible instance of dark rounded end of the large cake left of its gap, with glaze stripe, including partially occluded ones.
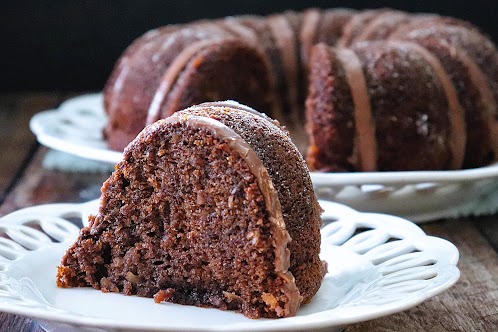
[147,39,272,124]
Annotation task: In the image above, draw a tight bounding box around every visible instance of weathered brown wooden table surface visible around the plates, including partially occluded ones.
[0,93,498,332]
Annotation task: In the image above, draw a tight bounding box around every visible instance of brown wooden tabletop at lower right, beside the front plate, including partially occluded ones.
[346,217,498,332]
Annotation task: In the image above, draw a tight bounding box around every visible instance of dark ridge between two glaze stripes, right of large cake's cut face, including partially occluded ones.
[354,43,462,170]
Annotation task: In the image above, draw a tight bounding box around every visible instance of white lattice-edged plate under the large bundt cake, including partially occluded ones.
[30,94,498,222]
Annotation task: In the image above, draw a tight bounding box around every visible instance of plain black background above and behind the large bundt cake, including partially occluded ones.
[0,0,498,92]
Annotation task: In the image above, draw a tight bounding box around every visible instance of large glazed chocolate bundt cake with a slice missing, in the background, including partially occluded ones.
[105,9,498,171]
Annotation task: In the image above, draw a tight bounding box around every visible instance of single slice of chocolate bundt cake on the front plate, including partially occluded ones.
[57,102,326,318]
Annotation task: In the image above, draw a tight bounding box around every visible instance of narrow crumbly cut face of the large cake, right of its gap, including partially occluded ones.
[306,44,357,172]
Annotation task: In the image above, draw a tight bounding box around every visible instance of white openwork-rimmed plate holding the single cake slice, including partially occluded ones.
[0,201,460,332]
